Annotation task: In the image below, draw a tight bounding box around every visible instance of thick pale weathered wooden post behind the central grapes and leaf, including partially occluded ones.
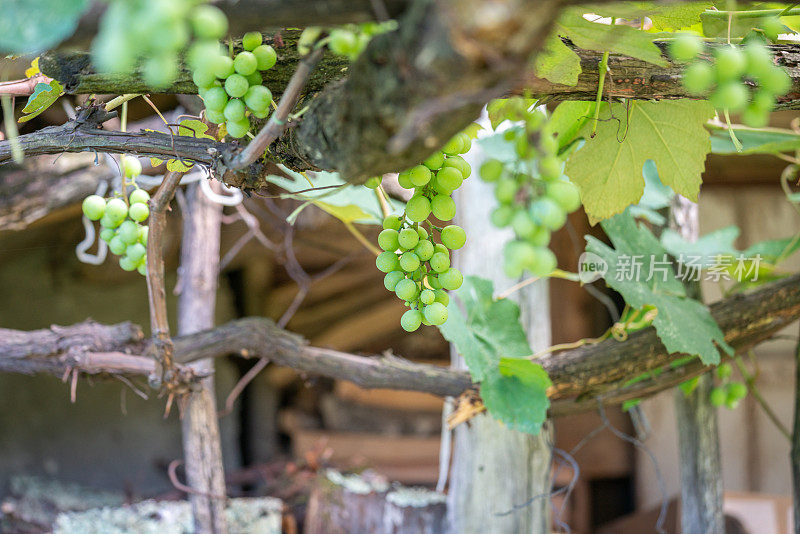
[447,141,552,534]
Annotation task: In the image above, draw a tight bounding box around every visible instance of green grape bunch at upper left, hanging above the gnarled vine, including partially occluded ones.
[189,13,278,139]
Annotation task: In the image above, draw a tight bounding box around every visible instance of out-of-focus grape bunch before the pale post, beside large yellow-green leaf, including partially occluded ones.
[479,101,581,278]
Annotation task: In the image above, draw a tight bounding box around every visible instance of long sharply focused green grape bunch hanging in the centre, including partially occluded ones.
[372,133,472,332]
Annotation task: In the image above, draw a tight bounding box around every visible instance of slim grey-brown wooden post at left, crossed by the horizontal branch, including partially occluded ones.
[178,182,227,534]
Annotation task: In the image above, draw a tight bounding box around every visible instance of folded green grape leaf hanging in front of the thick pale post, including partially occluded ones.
[439,276,551,434]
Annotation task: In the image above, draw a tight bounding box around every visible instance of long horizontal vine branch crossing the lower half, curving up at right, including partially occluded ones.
[0,275,800,416]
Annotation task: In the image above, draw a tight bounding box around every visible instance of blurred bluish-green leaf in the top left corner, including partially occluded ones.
[0,0,90,54]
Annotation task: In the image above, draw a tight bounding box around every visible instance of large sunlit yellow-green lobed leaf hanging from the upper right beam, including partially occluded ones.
[565,100,714,224]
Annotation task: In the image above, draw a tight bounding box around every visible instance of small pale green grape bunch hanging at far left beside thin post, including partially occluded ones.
[82,156,150,276]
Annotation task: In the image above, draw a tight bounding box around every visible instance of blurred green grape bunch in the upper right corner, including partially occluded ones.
[669,33,792,128]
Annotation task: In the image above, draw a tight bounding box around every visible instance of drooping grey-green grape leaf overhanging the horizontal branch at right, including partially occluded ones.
[586,211,733,365]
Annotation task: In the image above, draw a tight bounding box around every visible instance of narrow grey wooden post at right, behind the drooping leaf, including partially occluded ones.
[670,195,725,534]
